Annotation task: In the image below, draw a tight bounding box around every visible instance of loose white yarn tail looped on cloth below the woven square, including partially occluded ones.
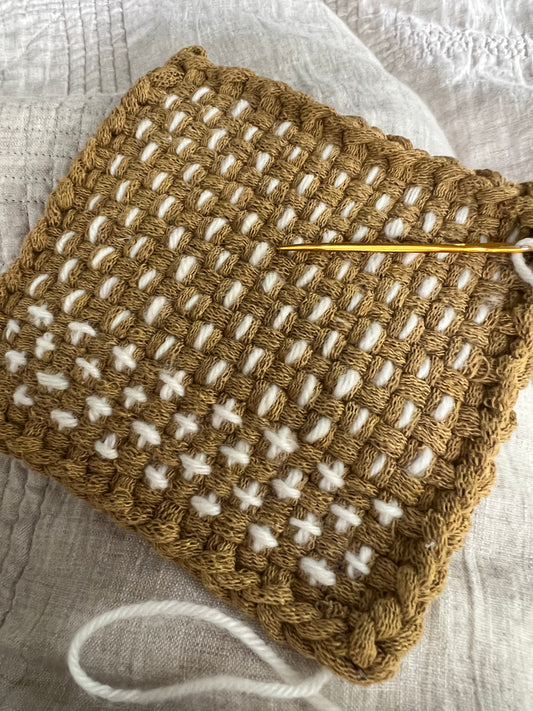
[67,600,341,711]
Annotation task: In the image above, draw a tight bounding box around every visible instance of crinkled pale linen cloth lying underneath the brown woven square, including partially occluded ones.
[0,0,533,711]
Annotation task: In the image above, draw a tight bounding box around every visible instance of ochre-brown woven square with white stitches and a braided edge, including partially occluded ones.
[0,48,533,683]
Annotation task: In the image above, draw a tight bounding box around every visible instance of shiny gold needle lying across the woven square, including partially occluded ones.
[278,242,533,254]
